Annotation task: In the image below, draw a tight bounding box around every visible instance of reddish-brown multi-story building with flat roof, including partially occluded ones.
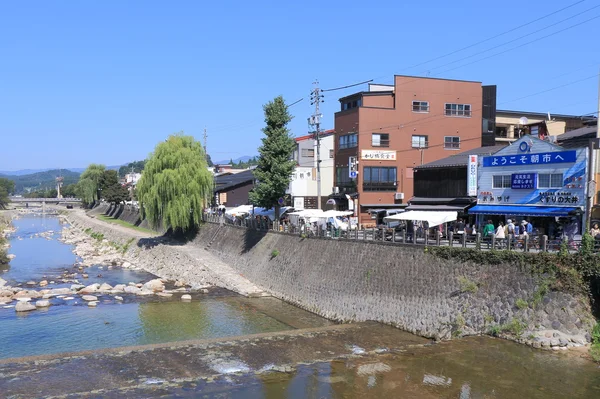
[333,75,496,226]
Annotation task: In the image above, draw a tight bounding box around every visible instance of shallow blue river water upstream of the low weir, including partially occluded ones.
[0,216,330,359]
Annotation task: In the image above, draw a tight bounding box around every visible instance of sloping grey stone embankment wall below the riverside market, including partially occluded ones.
[196,224,594,347]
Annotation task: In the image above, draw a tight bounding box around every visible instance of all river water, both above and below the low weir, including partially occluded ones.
[0,216,600,399]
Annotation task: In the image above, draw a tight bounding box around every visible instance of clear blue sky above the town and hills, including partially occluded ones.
[0,0,600,170]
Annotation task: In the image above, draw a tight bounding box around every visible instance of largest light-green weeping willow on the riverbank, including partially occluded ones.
[136,134,213,232]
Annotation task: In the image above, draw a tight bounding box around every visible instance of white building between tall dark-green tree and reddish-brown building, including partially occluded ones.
[287,130,334,209]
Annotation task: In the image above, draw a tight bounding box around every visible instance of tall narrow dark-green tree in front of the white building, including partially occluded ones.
[250,96,296,220]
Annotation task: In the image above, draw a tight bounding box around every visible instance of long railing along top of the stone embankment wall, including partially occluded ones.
[203,213,600,253]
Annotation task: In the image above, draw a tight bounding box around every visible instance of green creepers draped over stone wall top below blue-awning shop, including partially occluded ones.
[428,247,600,293]
